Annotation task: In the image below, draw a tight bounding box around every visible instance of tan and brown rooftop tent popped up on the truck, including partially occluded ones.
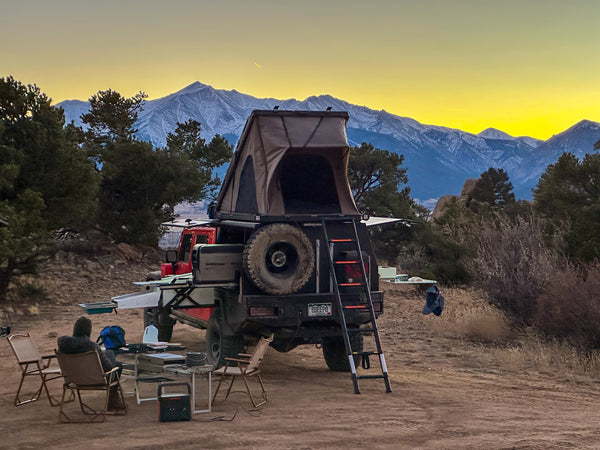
[215,111,360,220]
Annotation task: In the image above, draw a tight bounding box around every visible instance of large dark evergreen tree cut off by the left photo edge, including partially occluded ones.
[0,77,98,295]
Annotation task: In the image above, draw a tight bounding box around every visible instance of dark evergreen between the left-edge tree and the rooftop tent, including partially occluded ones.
[82,90,232,245]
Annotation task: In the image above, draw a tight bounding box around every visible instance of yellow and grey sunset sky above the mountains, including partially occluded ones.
[0,0,600,139]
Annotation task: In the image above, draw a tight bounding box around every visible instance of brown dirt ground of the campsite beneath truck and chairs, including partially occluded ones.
[0,251,600,449]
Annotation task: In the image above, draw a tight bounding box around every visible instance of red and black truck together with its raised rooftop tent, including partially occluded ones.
[129,110,383,371]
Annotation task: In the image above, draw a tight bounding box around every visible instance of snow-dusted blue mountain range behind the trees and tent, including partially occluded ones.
[57,82,600,204]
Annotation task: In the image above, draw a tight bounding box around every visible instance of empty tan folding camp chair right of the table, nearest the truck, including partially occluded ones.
[212,333,273,408]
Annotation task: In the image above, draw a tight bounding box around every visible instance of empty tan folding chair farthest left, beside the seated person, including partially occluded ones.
[8,333,60,406]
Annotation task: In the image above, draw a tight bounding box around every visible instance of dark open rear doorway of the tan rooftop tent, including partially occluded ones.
[279,154,341,214]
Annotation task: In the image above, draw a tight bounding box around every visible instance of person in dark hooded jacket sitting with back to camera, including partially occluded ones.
[57,317,124,411]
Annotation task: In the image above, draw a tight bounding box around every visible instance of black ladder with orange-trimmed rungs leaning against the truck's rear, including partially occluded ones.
[321,218,392,394]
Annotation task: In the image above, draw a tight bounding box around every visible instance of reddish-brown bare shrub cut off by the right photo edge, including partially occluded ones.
[534,263,600,350]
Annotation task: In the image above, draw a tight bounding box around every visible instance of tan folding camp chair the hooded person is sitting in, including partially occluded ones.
[54,350,127,422]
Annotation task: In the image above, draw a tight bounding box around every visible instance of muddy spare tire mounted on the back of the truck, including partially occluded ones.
[242,223,315,295]
